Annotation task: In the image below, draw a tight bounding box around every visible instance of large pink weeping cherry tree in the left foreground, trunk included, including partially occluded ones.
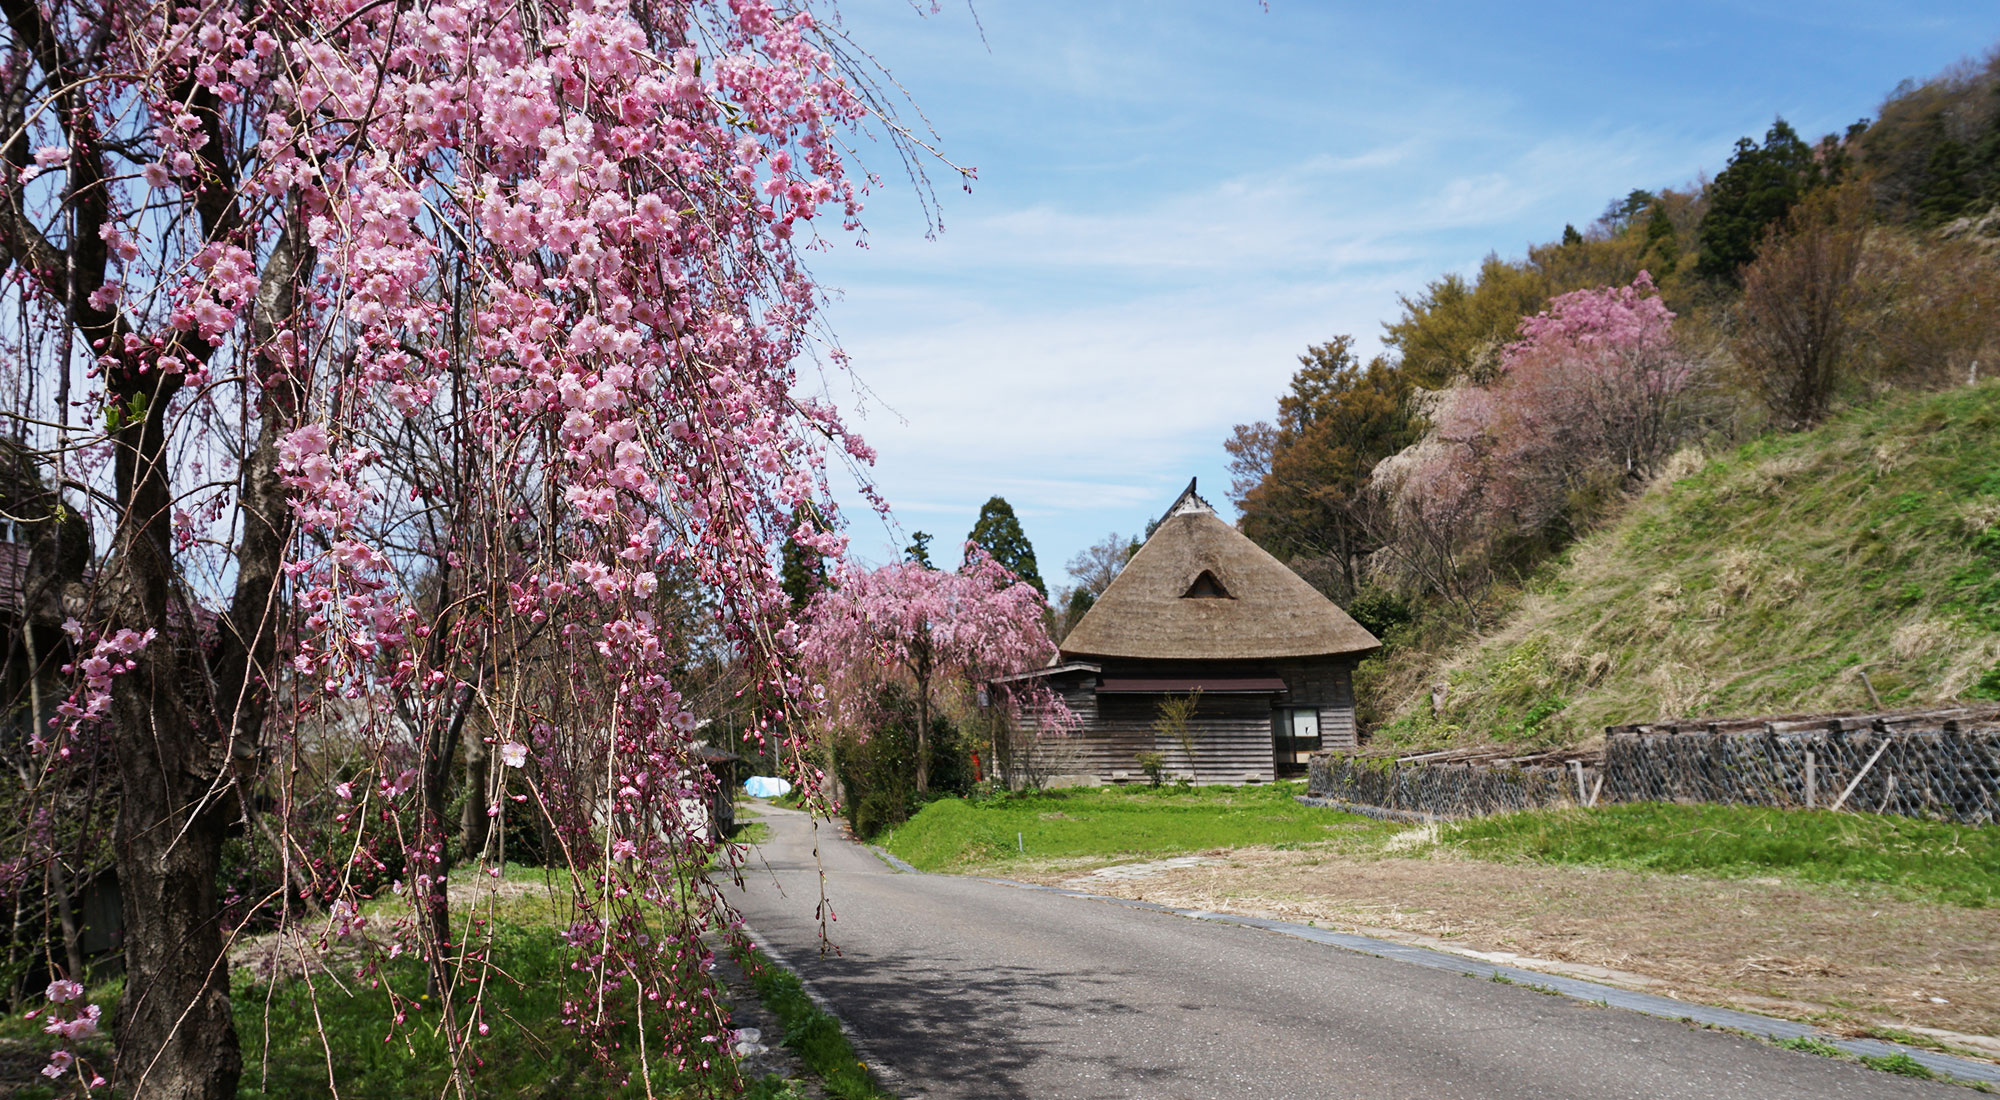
[0,0,956,1100]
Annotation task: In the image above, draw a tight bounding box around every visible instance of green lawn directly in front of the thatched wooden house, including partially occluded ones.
[882,782,1392,870]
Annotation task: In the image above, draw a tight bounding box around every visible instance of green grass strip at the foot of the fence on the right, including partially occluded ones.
[1438,802,2000,908]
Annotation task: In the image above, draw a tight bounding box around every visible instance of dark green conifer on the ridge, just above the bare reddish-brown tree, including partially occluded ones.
[1694,118,1822,284]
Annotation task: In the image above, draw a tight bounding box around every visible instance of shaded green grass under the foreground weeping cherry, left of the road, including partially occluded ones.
[0,860,886,1100]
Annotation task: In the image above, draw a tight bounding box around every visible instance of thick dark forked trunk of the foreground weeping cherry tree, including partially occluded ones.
[104,207,312,1100]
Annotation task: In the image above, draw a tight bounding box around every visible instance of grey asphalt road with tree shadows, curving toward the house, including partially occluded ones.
[734,808,1970,1100]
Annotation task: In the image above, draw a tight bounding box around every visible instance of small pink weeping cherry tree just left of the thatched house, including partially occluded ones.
[802,542,1060,794]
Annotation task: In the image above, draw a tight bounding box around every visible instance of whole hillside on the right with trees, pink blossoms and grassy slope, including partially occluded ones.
[1226,50,2000,742]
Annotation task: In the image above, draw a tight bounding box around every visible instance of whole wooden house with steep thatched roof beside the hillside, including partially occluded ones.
[996,482,1380,782]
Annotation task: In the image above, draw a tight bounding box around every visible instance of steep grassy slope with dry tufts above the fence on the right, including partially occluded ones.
[1376,382,2000,746]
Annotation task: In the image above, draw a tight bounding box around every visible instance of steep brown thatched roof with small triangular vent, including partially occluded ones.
[1062,482,1382,660]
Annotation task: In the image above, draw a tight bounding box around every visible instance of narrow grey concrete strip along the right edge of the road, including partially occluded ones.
[980,878,2000,1086]
